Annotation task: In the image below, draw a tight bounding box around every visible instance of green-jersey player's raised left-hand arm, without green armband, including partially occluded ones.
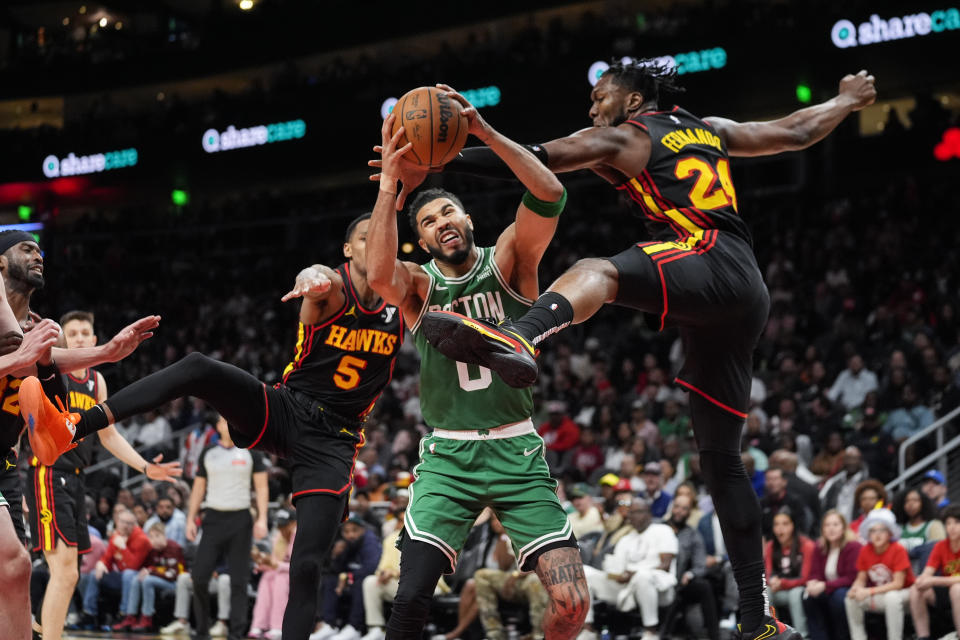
[367,113,429,320]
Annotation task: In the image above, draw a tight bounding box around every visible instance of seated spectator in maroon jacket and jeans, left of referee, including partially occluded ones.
[113,522,186,632]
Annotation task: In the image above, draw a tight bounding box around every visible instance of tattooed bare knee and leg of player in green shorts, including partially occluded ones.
[537,547,590,640]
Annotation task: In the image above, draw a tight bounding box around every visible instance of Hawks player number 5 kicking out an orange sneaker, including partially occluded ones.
[20,214,403,640]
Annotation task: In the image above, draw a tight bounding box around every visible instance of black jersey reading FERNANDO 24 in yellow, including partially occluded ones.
[617,107,750,245]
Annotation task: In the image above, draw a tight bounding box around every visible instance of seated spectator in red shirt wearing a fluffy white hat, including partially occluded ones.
[844,509,914,640]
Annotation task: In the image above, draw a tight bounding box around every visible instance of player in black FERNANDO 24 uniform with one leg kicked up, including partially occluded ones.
[384,61,876,640]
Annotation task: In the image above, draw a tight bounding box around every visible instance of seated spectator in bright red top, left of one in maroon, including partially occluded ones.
[83,508,153,628]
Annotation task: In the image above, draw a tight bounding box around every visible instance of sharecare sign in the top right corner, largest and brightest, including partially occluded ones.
[830,8,960,49]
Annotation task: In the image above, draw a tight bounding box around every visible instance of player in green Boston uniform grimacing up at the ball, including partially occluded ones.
[367,93,589,640]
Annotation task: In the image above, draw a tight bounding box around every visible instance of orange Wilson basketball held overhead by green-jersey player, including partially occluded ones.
[393,87,469,167]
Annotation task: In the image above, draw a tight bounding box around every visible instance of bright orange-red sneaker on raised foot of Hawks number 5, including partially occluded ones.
[20,376,80,466]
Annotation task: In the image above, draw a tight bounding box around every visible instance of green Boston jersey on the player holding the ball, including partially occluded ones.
[411,247,533,431]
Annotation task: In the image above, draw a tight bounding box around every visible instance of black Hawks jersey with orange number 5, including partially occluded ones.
[283,264,403,419]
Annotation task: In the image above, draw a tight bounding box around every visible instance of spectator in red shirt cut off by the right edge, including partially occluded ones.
[910,504,960,640]
